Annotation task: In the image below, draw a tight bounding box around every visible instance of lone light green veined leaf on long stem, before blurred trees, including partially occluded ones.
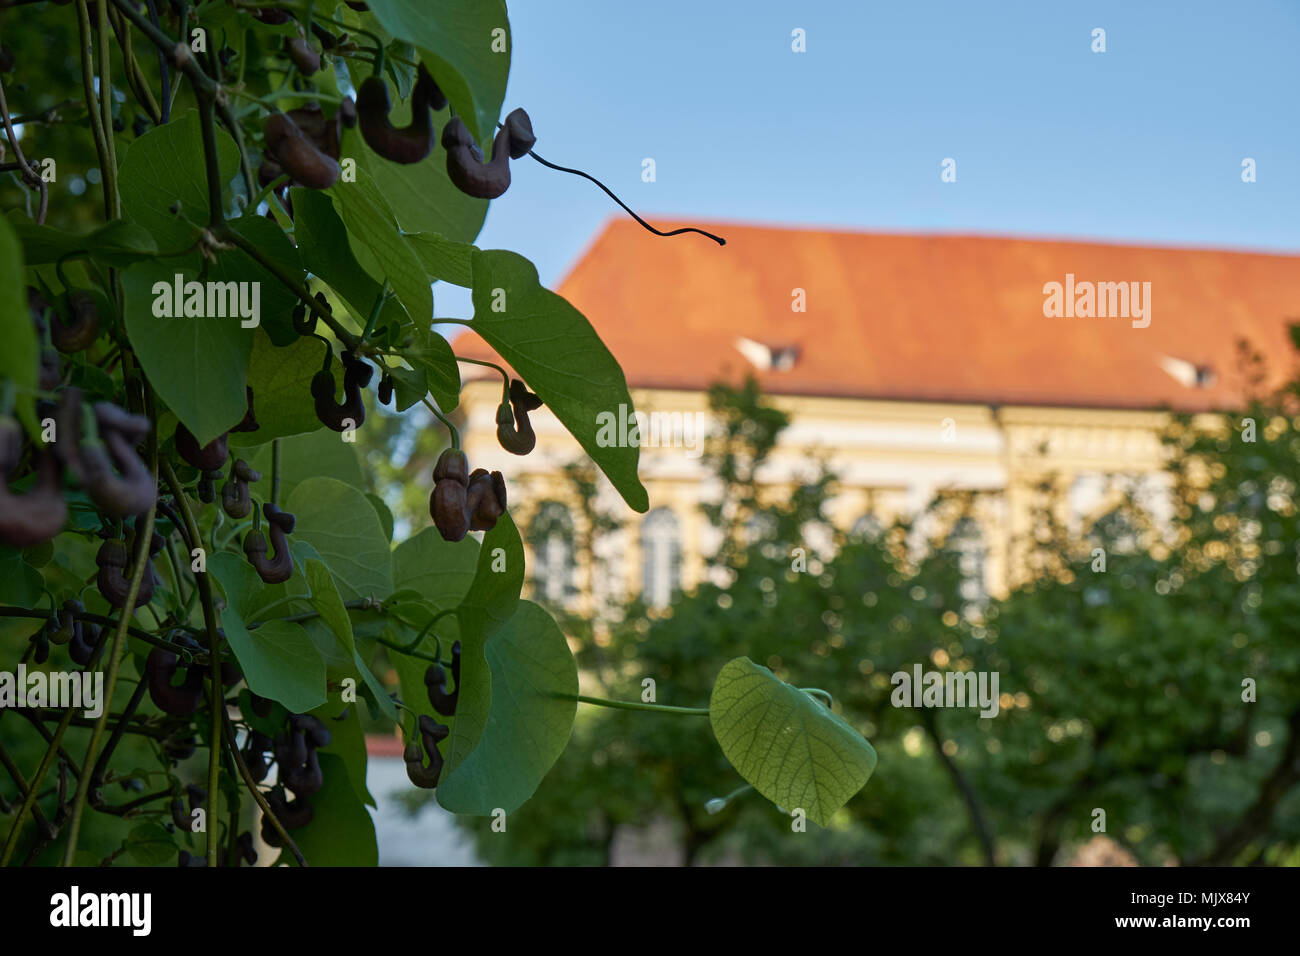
[709,657,876,826]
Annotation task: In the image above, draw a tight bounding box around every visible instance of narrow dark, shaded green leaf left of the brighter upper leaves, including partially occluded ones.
[290,187,411,335]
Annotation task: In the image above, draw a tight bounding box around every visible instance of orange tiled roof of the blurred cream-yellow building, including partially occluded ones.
[456,220,1300,410]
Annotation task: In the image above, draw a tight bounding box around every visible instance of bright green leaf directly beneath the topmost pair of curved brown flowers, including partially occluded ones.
[345,128,488,244]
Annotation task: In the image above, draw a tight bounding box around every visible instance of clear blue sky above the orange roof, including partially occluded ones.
[438,0,1300,315]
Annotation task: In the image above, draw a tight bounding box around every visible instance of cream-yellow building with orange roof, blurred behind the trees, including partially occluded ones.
[455,220,1300,602]
